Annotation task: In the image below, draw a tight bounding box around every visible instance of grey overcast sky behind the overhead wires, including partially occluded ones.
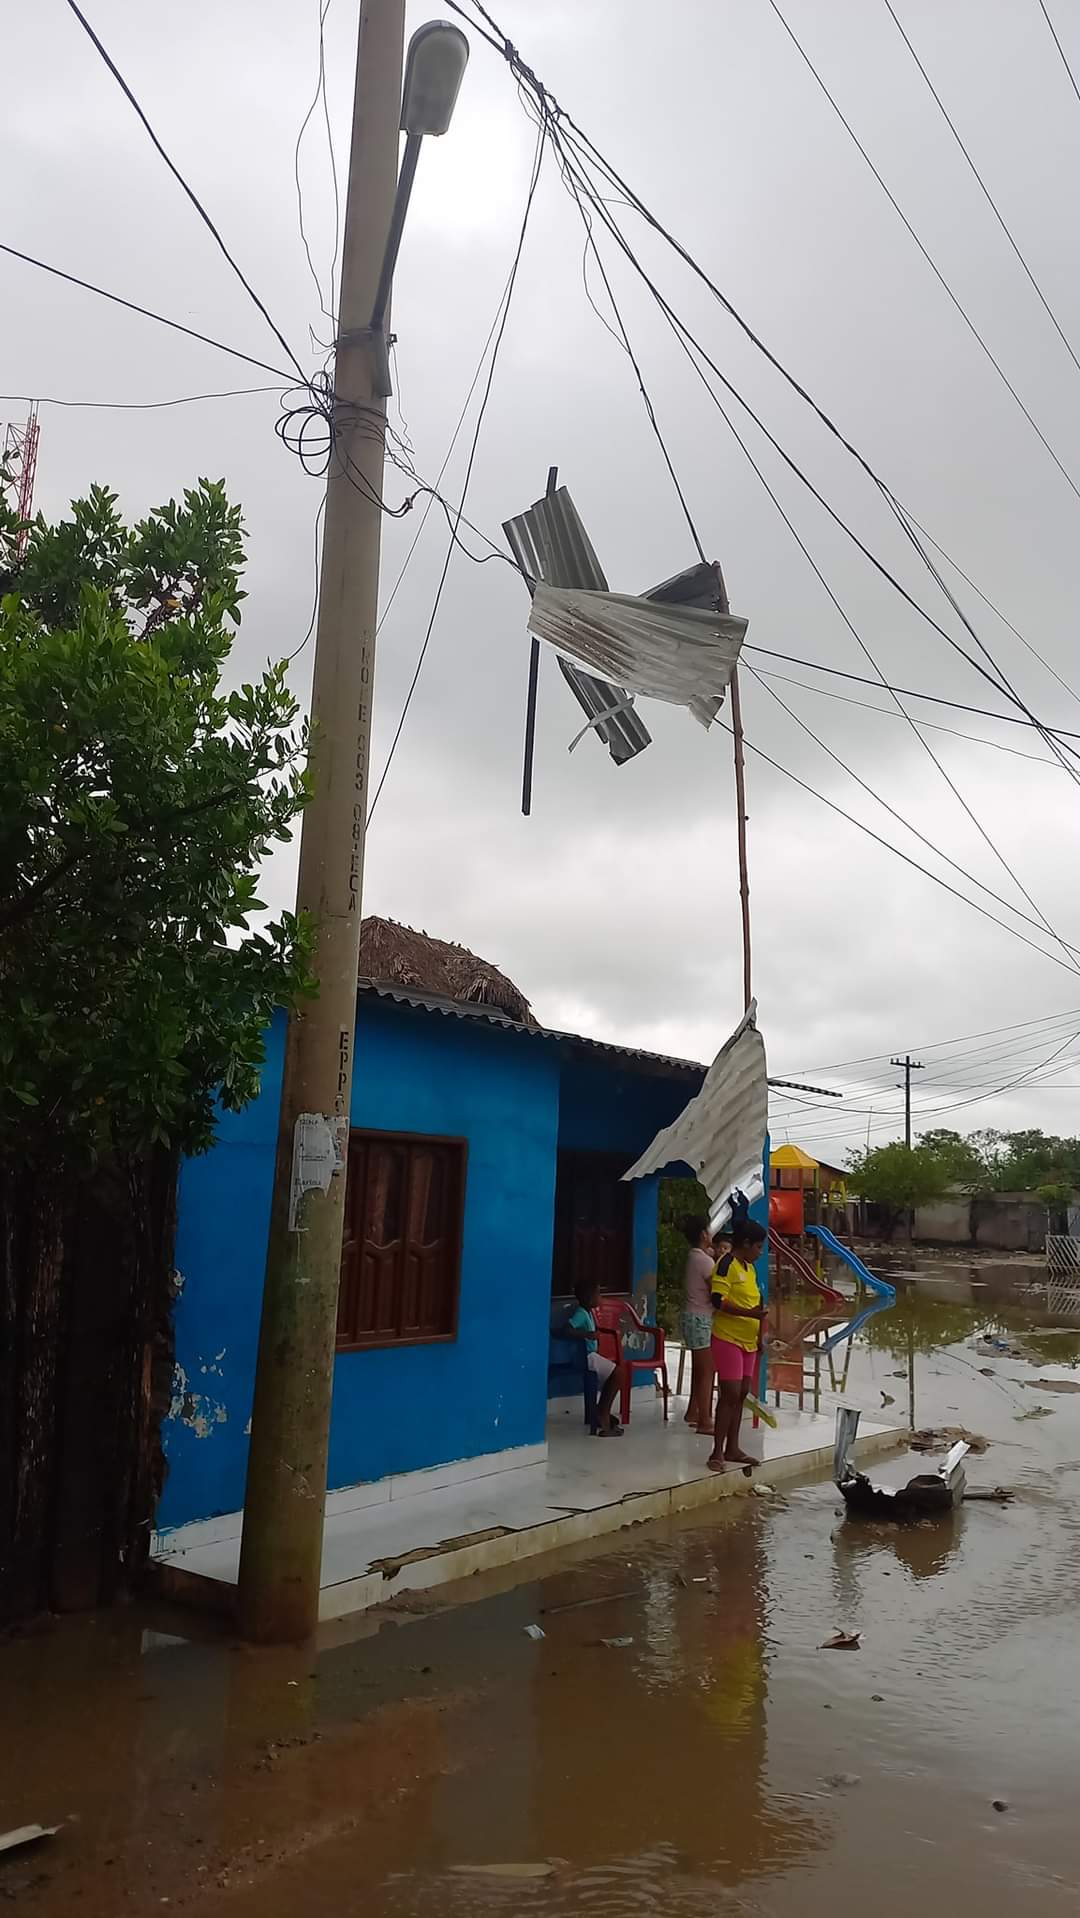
[0,0,1080,1158]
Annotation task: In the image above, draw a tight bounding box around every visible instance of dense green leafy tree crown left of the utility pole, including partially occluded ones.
[0,480,311,1158]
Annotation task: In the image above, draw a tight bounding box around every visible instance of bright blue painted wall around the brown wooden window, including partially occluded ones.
[157,1001,563,1527]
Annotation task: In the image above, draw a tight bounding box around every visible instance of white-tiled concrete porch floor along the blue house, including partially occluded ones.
[153,1392,904,1621]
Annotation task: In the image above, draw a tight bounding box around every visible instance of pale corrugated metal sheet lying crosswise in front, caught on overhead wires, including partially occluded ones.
[529,583,746,727]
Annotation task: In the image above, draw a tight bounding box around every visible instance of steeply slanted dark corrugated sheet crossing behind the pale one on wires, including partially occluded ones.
[503,485,652,765]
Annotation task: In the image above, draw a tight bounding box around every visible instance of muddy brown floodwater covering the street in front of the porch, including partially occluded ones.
[0,1262,1080,1918]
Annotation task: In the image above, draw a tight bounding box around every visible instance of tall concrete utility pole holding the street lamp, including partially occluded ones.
[240,0,405,1642]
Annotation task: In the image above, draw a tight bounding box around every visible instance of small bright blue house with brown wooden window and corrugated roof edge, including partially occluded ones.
[157,921,704,1531]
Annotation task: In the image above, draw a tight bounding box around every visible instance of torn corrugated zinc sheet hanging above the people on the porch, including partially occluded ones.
[623,999,769,1228]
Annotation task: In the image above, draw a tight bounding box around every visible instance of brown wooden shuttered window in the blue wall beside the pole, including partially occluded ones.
[338,1132,466,1352]
